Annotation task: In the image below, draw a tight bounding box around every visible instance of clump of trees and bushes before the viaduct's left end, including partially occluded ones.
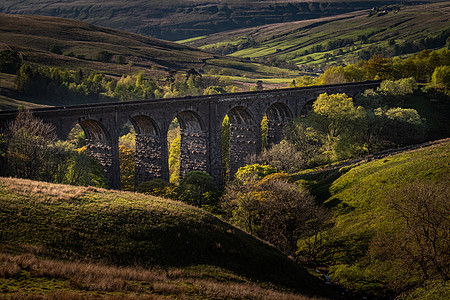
[2,110,106,187]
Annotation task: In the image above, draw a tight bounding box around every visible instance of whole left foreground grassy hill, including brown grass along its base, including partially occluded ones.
[0,178,326,298]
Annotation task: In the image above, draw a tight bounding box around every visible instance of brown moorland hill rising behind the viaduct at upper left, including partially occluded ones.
[0,14,299,108]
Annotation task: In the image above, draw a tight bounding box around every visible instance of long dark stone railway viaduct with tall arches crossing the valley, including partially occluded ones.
[0,81,380,189]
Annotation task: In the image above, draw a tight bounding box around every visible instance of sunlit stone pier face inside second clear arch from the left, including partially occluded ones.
[135,134,163,186]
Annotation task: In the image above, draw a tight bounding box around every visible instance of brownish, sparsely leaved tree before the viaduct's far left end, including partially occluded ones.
[6,109,56,180]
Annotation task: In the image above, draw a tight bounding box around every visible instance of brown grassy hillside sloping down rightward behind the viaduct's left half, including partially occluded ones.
[0,14,298,77]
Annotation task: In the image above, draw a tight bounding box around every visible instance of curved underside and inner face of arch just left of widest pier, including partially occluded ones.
[176,110,208,180]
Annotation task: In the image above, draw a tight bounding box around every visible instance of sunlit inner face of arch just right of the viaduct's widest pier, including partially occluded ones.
[228,106,261,179]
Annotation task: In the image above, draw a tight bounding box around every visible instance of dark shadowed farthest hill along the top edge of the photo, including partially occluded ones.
[0,0,434,40]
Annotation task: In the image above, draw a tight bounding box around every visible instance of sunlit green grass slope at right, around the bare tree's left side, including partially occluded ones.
[296,139,450,292]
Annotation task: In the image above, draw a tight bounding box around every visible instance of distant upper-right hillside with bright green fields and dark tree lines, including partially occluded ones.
[185,1,450,64]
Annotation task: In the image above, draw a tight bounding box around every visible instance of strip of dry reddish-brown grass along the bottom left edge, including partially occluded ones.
[0,253,324,300]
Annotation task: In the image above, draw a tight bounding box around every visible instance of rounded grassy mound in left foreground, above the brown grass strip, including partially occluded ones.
[0,178,326,294]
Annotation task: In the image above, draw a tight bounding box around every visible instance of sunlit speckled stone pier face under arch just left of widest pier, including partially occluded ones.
[180,129,208,181]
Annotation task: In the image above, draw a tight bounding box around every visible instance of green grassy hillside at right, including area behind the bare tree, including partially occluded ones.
[296,139,450,299]
